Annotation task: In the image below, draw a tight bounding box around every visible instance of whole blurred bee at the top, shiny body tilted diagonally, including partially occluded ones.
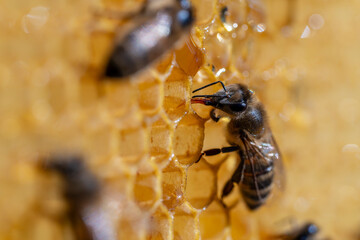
[104,0,194,78]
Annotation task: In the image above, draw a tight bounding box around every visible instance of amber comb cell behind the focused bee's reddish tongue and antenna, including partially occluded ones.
[191,66,217,119]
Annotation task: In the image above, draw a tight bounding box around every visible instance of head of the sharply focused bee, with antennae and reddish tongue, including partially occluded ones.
[191,81,253,115]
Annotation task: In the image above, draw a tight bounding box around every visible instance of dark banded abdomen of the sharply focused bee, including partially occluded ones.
[240,158,274,210]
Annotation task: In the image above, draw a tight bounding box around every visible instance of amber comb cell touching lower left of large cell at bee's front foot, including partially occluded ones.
[162,160,185,210]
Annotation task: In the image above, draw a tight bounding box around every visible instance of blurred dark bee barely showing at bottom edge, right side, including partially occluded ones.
[270,223,319,240]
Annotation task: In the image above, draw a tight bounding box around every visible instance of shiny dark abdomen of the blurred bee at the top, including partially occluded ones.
[105,10,176,78]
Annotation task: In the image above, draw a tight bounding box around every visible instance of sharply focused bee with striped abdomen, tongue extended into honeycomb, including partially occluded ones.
[191,81,284,210]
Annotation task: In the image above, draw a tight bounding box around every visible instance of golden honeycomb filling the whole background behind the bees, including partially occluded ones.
[0,0,360,240]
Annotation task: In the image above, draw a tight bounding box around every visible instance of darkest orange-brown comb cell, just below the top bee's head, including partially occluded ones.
[175,36,204,77]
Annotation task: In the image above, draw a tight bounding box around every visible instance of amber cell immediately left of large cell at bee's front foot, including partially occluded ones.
[150,116,172,167]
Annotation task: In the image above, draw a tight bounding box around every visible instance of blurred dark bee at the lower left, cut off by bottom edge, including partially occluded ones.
[43,155,116,240]
